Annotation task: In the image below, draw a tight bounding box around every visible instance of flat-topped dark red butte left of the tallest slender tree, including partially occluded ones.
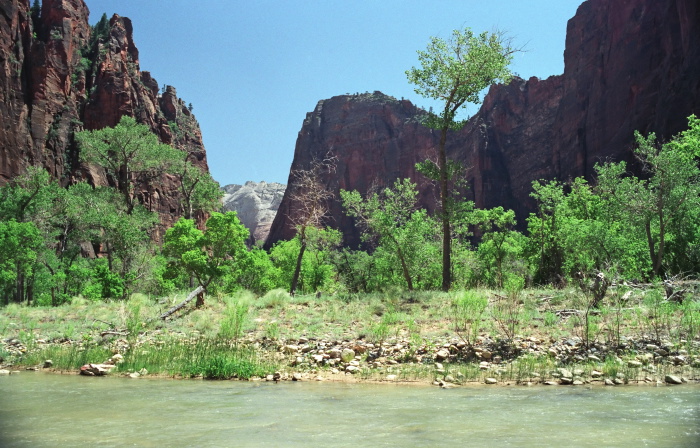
[266,92,438,246]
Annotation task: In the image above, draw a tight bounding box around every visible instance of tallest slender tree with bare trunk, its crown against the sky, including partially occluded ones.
[406,28,516,291]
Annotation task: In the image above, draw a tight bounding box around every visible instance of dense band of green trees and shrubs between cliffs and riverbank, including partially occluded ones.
[0,108,700,306]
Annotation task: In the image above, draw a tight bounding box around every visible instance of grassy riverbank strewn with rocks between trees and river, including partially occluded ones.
[0,287,700,386]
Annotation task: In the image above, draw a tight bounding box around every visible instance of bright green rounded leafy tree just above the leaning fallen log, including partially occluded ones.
[163,212,248,307]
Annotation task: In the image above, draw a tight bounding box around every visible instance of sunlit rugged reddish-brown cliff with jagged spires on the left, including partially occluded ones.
[0,0,208,238]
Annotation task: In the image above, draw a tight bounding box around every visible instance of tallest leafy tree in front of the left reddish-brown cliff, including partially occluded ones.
[75,115,182,213]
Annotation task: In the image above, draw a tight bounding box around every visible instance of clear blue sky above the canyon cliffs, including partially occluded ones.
[85,0,582,185]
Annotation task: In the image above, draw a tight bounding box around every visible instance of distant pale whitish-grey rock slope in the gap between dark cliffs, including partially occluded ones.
[221,181,287,244]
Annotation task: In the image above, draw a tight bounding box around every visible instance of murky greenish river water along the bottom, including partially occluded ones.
[0,372,700,447]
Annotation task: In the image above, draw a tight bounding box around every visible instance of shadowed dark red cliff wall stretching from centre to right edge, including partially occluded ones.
[266,0,700,246]
